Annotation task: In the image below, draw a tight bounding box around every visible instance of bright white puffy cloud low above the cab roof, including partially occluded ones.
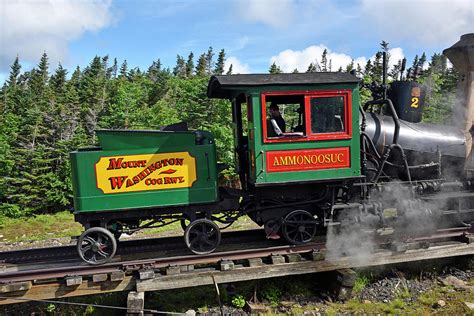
[270,45,367,72]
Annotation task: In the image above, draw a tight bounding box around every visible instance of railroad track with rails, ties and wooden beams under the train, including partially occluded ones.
[0,228,474,305]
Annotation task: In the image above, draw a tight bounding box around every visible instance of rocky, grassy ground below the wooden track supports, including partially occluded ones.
[0,257,474,316]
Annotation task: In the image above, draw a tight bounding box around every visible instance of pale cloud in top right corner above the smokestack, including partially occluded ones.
[361,0,474,44]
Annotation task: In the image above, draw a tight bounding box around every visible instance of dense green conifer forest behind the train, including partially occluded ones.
[0,42,458,218]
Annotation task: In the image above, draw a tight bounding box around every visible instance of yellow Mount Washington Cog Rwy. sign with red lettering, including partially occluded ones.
[95,152,196,194]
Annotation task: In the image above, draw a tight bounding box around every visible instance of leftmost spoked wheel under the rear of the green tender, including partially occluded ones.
[77,227,117,265]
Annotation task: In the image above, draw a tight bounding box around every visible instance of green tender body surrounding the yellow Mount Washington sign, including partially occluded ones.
[70,130,219,212]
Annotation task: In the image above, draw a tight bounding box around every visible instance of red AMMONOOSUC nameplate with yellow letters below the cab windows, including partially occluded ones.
[266,147,350,172]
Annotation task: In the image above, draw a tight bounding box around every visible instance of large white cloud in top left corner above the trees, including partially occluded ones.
[0,0,112,71]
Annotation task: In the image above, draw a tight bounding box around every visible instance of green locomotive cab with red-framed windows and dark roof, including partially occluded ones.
[208,73,360,191]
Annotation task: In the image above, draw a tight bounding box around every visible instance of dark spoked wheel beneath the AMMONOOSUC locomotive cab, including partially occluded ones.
[281,210,317,245]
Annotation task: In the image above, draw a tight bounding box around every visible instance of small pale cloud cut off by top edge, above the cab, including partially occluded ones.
[239,0,294,28]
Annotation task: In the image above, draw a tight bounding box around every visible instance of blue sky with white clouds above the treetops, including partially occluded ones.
[0,0,474,83]
